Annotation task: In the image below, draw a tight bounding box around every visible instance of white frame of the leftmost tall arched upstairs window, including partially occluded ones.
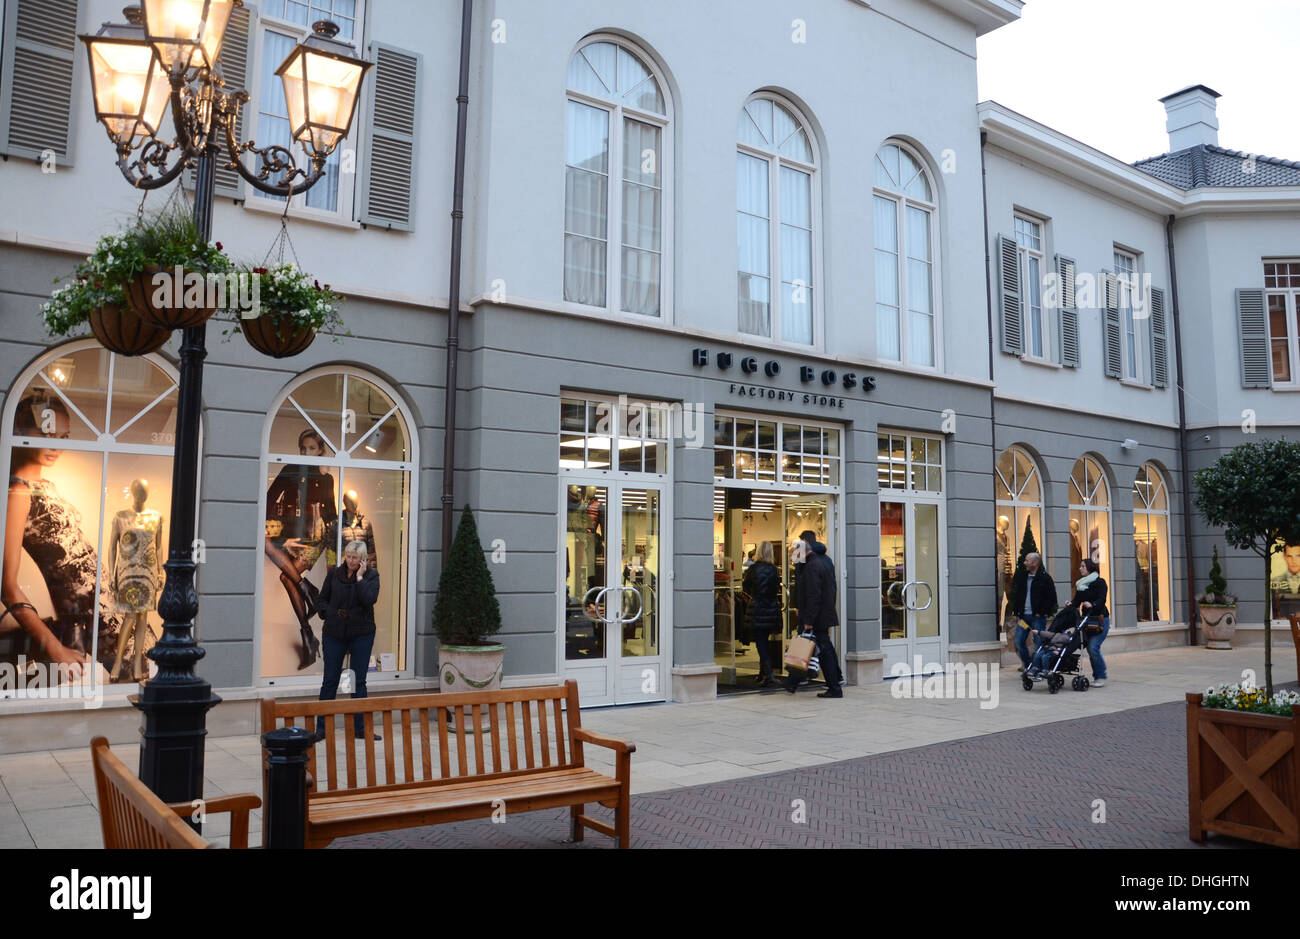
[560,33,673,324]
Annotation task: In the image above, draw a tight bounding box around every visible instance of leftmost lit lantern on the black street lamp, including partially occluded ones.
[81,8,172,144]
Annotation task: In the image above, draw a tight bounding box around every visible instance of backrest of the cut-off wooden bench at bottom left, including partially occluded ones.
[90,737,212,849]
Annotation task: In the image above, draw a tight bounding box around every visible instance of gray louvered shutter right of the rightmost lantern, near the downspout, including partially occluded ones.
[359,43,423,231]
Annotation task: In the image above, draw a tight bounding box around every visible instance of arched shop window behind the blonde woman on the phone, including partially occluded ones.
[260,367,419,680]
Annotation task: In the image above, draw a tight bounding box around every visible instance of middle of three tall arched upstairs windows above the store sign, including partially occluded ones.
[736,94,820,345]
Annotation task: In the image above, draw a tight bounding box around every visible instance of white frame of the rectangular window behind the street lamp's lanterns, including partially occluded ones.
[243,0,374,222]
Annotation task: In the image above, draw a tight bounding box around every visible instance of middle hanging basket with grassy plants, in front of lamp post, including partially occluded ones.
[119,209,234,329]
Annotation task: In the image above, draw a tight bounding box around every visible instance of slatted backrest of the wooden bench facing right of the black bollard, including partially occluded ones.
[261,681,584,797]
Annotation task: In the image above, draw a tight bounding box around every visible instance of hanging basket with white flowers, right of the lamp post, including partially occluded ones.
[228,264,343,359]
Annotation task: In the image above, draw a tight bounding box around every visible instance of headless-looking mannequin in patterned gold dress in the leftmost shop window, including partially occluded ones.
[108,480,163,681]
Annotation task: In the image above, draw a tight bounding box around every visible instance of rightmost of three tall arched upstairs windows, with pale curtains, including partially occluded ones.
[872,143,937,367]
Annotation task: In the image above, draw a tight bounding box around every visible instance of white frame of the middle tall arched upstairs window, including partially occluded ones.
[733,91,826,352]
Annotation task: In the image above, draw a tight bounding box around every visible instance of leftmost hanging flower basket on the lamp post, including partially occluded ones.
[40,247,172,355]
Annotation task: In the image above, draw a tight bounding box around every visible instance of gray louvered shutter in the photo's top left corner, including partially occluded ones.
[0,0,80,166]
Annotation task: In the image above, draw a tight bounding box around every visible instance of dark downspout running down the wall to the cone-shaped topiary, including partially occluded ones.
[442,0,473,556]
